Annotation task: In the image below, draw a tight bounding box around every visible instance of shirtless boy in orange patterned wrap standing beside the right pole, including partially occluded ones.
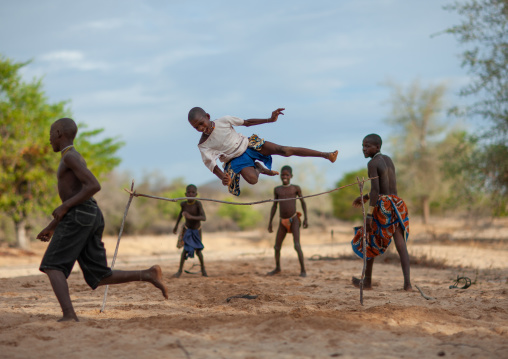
[351,134,412,291]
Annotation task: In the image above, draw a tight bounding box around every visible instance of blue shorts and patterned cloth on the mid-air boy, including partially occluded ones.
[224,135,272,196]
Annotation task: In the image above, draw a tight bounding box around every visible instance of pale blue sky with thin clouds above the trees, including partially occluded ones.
[0,0,468,188]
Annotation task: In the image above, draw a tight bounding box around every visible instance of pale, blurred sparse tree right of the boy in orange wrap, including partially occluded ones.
[387,81,454,223]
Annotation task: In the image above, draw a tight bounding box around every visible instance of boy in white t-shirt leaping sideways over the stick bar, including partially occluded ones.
[188,107,339,196]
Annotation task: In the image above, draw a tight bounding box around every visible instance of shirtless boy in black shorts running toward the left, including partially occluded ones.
[37,118,168,322]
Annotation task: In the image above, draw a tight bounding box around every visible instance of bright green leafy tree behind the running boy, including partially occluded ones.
[0,56,122,248]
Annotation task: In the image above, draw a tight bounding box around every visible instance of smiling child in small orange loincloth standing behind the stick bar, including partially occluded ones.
[267,166,307,277]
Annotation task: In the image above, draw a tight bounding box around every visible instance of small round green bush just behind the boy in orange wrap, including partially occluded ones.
[330,166,370,220]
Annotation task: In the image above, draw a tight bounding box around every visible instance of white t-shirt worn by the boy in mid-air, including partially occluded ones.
[198,116,249,172]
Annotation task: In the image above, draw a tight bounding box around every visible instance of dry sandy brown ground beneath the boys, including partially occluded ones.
[0,221,508,359]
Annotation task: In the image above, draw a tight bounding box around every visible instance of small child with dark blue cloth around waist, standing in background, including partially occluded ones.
[173,184,208,278]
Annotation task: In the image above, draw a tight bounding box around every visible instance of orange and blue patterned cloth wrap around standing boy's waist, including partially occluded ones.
[351,194,409,259]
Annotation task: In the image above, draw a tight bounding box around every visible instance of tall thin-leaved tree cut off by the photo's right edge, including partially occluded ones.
[445,0,508,208]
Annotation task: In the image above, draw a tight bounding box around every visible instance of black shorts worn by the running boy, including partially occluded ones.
[39,198,113,289]
